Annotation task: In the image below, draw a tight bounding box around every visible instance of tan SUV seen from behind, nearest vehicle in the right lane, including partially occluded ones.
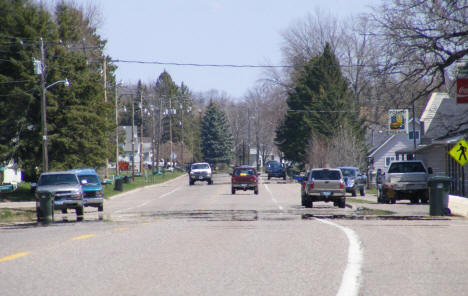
[300,168,346,208]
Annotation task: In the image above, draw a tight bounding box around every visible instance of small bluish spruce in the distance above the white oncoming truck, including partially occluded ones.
[201,102,232,164]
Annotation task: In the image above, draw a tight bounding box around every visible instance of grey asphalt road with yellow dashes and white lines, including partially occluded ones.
[0,175,468,296]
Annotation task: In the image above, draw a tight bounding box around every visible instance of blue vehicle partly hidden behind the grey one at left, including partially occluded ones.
[68,169,104,212]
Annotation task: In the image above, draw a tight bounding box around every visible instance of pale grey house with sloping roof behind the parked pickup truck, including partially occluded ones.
[367,119,422,183]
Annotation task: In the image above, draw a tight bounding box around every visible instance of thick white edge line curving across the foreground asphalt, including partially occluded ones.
[316,218,363,296]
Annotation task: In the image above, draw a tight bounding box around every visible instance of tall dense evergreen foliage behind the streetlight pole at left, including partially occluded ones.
[0,0,115,181]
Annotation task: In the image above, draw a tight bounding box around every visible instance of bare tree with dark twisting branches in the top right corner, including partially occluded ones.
[369,0,468,101]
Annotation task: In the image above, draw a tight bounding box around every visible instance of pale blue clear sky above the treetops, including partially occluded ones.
[75,0,377,99]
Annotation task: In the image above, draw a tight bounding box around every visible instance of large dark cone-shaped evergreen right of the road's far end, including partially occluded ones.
[275,44,361,163]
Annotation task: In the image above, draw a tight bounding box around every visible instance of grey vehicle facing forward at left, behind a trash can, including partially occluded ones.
[35,171,86,221]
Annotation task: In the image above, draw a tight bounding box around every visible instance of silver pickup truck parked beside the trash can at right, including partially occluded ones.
[377,160,432,203]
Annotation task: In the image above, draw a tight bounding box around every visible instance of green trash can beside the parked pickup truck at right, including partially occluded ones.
[427,176,452,216]
